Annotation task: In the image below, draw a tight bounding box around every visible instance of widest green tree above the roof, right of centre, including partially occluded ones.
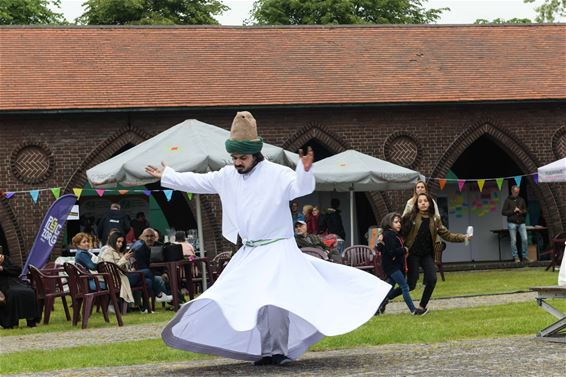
[245,0,449,25]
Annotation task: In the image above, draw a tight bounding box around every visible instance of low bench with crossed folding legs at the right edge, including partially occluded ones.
[530,285,566,343]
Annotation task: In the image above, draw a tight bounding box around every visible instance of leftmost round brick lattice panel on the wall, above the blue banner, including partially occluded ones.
[10,142,54,183]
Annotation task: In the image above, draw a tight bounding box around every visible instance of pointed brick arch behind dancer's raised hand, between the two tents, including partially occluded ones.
[282,123,390,229]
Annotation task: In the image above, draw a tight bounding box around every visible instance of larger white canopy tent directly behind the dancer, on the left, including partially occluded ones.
[86,119,299,285]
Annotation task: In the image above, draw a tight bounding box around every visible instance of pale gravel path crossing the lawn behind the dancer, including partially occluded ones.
[0,292,536,354]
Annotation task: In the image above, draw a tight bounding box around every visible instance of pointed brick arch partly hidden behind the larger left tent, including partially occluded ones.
[63,125,220,251]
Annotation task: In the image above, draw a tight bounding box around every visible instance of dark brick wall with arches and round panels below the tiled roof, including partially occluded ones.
[0,104,566,261]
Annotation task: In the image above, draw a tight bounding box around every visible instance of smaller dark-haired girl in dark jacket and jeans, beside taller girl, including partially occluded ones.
[376,212,422,315]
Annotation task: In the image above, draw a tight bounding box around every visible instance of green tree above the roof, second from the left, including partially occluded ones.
[77,0,230,25]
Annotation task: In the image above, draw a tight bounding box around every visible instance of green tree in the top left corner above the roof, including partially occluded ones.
[0,0,66,25]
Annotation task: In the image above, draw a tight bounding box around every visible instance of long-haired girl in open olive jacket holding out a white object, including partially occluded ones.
[401,193,472,315]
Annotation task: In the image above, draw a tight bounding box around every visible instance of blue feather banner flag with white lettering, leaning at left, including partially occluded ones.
[20,194,77,277]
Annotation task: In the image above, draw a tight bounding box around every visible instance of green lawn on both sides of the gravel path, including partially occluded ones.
[0,268,566,374]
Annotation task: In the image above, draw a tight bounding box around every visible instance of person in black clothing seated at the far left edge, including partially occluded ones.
[0,249,41,329]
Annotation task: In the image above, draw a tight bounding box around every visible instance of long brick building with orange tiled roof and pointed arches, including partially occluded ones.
[0,25,566,261]
